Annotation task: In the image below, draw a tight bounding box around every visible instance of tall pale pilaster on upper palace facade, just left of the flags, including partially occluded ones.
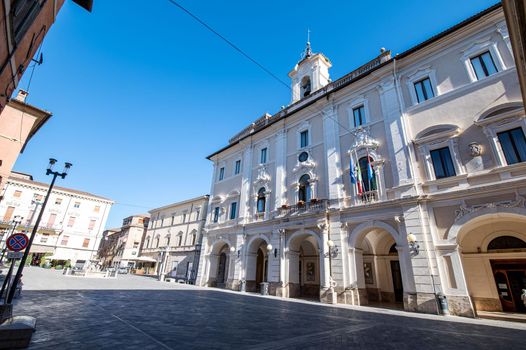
[322,104,343,206]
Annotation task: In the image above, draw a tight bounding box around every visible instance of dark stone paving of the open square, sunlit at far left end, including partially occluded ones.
[7,268,526,350]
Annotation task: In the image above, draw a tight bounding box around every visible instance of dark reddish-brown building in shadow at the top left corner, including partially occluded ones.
[0,0,93,112]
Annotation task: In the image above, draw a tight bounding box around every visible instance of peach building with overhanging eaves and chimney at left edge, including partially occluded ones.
[0,90,51,197]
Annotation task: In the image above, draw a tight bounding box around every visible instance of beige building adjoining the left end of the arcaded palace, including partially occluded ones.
[141,195,209,284]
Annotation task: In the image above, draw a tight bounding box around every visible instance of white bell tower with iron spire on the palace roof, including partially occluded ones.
[289,41,332,103]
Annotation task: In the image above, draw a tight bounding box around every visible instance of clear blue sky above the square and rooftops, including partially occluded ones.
[15,0,495,227]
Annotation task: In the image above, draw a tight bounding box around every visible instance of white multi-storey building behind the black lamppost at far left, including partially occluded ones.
[0,173,113,267]
